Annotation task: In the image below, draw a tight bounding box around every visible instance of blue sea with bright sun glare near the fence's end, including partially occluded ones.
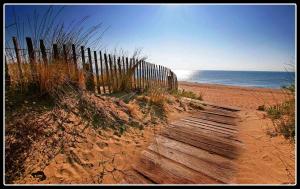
[174,70,295,89]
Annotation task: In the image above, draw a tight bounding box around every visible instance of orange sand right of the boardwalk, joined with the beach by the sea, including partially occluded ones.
[179,82,295,184]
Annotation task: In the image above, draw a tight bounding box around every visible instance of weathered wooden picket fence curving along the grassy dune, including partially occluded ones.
[5,37,178,94]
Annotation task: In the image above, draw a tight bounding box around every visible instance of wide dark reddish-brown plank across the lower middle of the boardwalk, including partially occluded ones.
[161,129,237,159]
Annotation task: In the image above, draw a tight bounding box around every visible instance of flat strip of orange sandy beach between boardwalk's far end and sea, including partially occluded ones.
[178,81,290,110]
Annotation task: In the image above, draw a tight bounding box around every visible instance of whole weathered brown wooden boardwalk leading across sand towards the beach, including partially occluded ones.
[122,101,242,184]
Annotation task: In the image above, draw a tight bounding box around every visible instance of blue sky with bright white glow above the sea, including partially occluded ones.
[5,4,295,71]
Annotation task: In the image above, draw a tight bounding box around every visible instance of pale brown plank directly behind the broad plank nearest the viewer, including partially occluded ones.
[148,137,233,183]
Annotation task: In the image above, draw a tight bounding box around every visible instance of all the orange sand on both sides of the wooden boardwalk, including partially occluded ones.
[7,82,295,184]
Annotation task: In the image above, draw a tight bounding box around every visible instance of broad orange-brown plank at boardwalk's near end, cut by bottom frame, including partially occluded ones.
[134,151,221,184]
